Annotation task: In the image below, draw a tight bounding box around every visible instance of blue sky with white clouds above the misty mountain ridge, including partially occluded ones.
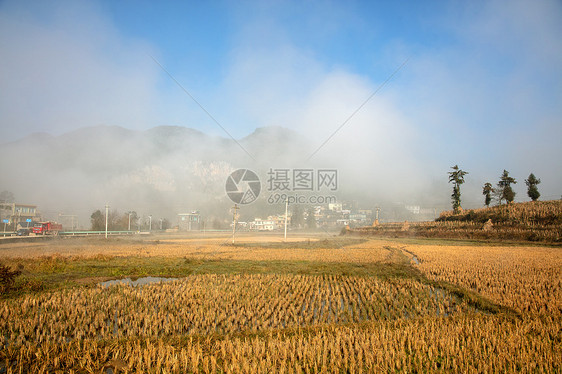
[0,0,562,203]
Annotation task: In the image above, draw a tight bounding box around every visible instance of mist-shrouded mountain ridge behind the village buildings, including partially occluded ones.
[0,127,446,226]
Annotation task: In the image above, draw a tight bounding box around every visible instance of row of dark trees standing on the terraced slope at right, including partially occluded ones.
[449,165,541,213]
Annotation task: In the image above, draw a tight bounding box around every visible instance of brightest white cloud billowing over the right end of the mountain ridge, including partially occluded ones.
[219,44,431,200]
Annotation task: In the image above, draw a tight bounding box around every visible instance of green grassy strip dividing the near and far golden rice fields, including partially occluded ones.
[4,254,421,297]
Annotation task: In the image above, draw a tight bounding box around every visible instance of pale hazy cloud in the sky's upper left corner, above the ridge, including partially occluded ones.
[0,2,159,139]
